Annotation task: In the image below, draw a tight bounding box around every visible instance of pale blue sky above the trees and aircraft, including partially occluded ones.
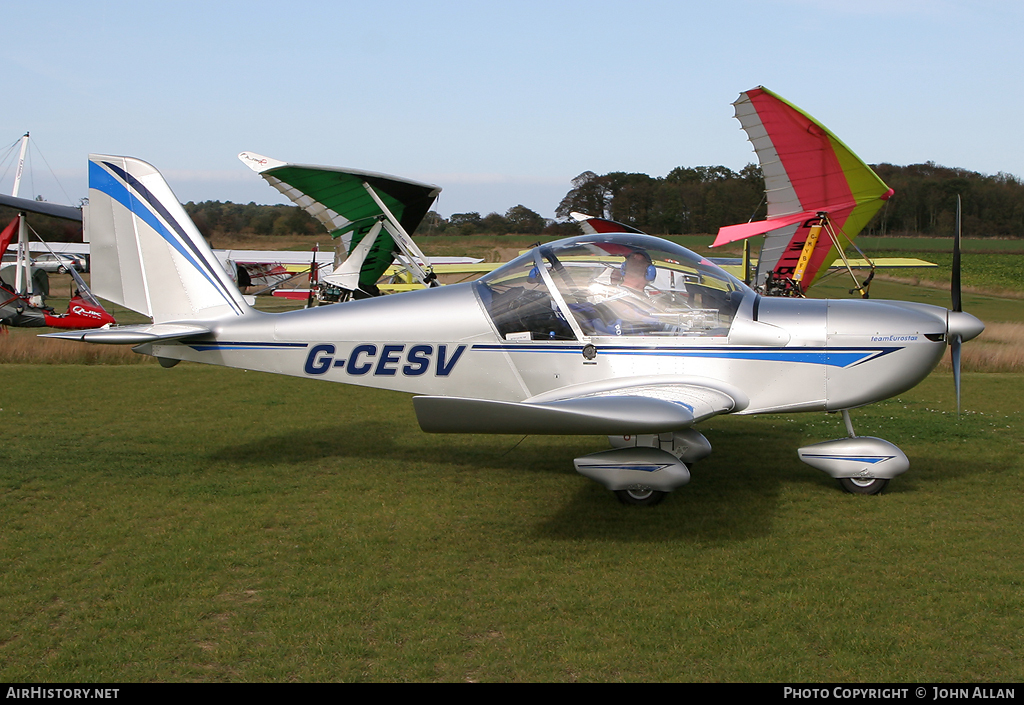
[0,0,1024,217]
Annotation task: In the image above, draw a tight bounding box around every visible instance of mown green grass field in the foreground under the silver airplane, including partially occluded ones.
[0,364,1024,682]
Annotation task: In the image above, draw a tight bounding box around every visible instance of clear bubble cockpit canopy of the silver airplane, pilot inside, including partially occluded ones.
[476,234,754,340]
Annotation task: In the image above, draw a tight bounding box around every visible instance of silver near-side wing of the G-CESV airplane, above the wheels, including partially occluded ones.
[413,384,745,436]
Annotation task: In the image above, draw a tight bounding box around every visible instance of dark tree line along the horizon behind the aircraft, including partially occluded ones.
[0,162,1024,242]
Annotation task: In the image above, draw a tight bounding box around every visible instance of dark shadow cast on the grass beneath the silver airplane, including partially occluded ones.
[208,418,1011,543]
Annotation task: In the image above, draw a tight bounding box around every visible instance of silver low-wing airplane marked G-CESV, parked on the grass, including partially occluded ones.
[48,155,984,505]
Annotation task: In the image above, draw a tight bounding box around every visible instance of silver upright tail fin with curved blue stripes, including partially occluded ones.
[87,155,249,323]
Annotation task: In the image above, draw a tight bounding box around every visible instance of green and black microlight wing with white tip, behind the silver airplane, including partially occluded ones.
[239,152,441,291]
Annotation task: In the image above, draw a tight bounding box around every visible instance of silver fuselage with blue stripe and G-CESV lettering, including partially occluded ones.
[138,283,948,414]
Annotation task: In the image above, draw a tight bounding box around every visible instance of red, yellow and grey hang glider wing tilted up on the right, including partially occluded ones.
[713,87,893,290]
